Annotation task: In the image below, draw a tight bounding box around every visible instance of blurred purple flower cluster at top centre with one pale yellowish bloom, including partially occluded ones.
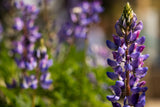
[59,0,103,41]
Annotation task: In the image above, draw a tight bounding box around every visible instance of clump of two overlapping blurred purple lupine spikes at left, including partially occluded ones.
[9,1,52,89]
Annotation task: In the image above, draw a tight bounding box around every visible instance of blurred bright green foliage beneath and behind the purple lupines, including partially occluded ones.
[0,41,113,107]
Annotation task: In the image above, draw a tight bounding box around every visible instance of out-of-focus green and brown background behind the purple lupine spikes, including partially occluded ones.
[0,0,160,107]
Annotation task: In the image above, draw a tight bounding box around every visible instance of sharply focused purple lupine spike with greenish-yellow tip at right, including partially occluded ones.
[106,3,149,107]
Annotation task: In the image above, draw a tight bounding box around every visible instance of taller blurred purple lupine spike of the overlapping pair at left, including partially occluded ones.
[13,1,41,70]
